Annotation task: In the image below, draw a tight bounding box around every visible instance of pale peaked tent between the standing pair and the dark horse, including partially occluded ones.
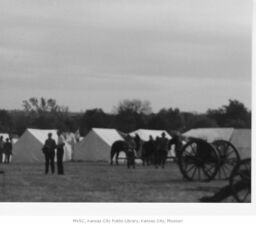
[74,128,124,161]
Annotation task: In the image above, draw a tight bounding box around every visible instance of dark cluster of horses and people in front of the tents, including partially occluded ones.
[110,134,181,168]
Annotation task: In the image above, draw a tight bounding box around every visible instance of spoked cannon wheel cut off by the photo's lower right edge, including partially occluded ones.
[229,159,251,202]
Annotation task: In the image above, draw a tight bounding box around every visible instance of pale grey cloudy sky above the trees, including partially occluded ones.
[0,0,252,112]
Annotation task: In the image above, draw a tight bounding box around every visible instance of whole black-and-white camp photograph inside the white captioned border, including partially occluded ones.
[0,0,253,204]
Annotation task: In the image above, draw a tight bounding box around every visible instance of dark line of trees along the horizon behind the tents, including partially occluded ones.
[0,97,251,136]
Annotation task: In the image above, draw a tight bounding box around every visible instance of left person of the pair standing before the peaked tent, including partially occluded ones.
[43,133,56,174]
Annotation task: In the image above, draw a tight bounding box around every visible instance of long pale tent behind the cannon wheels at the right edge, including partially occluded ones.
[183,128,251,159]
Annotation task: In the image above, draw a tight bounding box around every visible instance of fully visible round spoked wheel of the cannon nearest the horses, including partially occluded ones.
[178,139,218,181]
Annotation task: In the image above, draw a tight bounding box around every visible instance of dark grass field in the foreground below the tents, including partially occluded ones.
[0,162,233,202]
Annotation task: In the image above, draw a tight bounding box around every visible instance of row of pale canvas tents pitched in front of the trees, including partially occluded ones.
[9,128,251,162]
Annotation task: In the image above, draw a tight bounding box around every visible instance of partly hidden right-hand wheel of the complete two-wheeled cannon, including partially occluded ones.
[212,140,240,180]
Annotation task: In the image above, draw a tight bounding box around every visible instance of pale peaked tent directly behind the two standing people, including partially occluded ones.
[13,129,72,163]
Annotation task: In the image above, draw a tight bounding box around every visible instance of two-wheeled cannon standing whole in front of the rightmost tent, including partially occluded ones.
[177,138,240,181]
